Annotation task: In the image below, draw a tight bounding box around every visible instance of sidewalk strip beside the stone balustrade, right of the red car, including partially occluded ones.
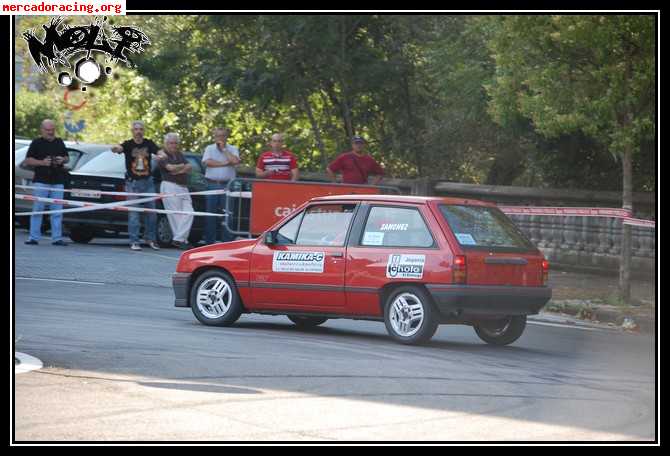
[544,270,657,332]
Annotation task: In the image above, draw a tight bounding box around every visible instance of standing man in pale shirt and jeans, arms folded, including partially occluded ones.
[202,128,240,244]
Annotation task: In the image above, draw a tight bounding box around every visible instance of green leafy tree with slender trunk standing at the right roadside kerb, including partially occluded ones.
[486,15,656,301]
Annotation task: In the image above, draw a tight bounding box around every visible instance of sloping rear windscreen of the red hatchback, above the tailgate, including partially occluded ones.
[440,204,535,250]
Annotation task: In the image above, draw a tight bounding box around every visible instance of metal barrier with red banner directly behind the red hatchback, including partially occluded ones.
[223,178,400,238]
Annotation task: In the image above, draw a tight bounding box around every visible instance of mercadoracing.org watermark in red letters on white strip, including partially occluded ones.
[0,0,126,16]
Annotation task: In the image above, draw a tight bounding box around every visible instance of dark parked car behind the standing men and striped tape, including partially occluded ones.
[63,150,220,246]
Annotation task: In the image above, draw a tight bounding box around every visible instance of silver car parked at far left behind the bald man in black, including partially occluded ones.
[14,140,111,228]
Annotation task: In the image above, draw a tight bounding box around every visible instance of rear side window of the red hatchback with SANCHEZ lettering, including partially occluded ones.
[360,206,434,247]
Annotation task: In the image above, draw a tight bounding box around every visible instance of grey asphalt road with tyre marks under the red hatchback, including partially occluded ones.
[13,230,656,442]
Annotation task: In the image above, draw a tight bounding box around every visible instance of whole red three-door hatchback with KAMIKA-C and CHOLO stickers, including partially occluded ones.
[173,195,551,345]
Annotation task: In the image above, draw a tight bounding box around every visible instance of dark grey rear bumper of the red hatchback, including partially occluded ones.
[426,284,551,318]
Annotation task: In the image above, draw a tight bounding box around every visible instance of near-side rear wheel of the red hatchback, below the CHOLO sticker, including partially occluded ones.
[384,286,439,344]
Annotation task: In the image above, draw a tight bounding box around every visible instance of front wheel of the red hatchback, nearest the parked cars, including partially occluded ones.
[191,271,243,326]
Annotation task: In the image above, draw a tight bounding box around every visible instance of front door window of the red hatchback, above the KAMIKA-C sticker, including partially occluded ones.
[296,204,356,247]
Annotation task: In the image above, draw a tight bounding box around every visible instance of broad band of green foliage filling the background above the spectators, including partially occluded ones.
[15,15,656,190]
